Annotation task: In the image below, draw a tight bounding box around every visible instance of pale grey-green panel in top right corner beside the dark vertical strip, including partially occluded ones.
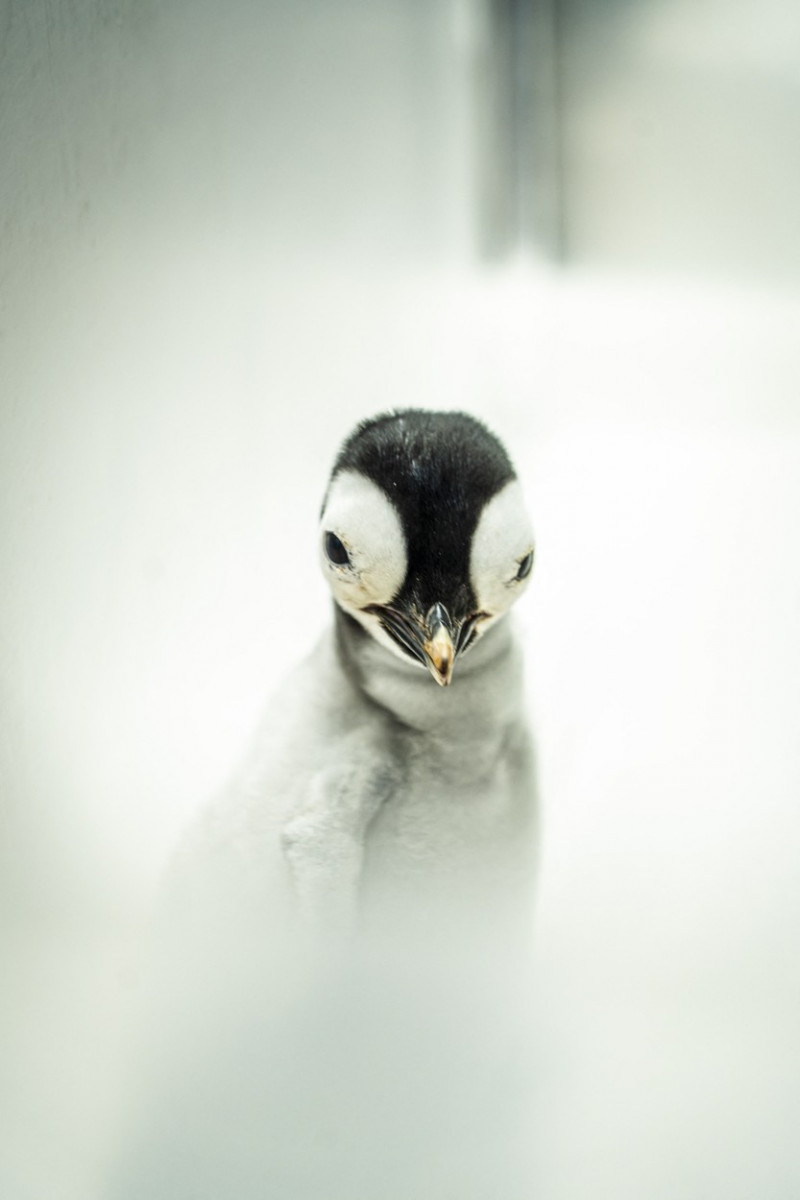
[558,0,800,286]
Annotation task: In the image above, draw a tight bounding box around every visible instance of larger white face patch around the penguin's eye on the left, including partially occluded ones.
[319,470,408,612]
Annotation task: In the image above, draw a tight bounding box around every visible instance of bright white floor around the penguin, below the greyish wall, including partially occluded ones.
[0,255,800,1200]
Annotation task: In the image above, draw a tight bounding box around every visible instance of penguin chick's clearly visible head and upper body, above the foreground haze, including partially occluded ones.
[170,409,535,950]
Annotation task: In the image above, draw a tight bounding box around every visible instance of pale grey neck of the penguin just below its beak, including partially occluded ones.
[333,604,522,742]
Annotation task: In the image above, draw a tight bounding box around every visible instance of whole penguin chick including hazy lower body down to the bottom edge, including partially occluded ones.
[108,408,537,1200]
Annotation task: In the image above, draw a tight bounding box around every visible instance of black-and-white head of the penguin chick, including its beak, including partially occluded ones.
[319,409,534,686]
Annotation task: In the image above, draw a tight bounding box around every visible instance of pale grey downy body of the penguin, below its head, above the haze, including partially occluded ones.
[170,610,536,960]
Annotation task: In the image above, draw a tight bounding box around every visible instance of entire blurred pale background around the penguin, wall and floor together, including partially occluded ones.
[0,0,800,1200]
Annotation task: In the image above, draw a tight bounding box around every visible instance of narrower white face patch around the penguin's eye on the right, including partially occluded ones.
[470,479,534,616]
